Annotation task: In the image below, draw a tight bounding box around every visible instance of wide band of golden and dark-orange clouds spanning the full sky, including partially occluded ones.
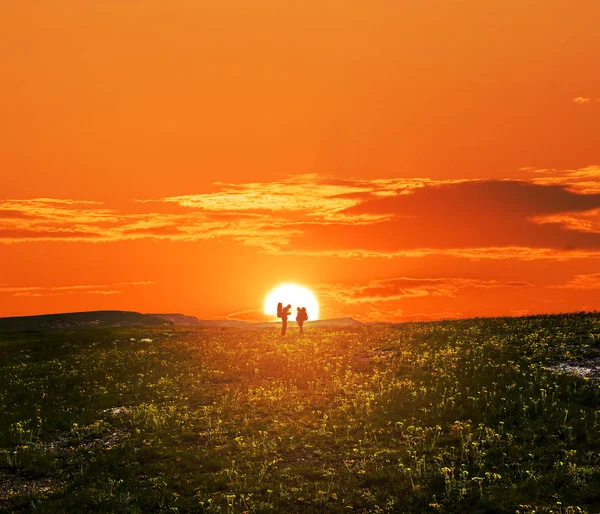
[0,172,600,259]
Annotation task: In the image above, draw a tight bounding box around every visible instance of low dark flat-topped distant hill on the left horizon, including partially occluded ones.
[0,311,173,330]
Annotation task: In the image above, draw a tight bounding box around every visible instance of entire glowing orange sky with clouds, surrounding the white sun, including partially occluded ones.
[0,0,600,321]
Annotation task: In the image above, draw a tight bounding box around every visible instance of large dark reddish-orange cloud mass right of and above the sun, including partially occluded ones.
[290,181,600,254]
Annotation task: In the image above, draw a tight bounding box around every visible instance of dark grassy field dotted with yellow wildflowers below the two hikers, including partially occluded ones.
[0,313,600,513]
